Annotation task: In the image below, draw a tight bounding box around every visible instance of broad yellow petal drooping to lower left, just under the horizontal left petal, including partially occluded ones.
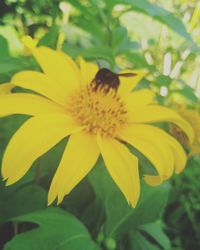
[2,114,81,185]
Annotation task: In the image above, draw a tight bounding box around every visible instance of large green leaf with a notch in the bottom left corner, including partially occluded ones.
[4,208,100,250]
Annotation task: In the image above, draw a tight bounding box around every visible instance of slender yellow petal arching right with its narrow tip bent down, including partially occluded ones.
[128,105,194,142]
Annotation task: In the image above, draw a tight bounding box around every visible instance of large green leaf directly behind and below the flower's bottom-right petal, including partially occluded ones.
[88,162,170,238]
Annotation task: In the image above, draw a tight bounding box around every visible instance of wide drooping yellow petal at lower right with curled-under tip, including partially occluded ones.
[120,124,186,183]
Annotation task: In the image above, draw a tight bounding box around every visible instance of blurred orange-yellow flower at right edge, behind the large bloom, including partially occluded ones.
[171,106,200,157]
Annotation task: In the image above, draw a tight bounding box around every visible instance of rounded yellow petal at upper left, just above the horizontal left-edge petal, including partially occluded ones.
[11,71,68,105]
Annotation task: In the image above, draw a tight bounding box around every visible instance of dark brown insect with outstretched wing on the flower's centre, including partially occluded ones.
[92,68,137,90]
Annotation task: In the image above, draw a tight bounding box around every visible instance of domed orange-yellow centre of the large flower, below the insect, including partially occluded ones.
[68,84,127,138]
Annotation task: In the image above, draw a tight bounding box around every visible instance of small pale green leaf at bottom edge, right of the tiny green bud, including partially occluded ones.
[140,221,171,250]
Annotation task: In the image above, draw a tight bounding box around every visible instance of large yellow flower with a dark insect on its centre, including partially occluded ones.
[0,47,193,206]
